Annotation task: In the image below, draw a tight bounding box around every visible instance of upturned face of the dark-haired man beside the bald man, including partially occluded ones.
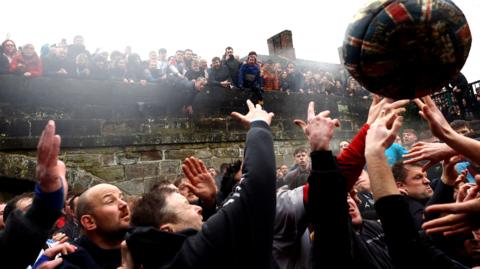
[166,192,203,232]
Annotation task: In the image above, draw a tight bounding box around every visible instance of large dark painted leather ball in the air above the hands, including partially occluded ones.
[342,0,472,99]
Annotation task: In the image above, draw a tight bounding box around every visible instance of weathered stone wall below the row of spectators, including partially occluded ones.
[0,76,369,194]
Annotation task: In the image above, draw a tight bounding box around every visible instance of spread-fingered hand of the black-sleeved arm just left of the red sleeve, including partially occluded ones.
[293,102,340,151]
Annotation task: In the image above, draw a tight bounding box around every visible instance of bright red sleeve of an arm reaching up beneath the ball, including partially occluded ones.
[337,124,370,191]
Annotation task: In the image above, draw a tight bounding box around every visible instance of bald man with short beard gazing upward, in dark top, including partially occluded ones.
[59,184,130,268]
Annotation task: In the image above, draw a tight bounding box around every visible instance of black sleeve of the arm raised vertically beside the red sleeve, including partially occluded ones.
[306,151,353,268]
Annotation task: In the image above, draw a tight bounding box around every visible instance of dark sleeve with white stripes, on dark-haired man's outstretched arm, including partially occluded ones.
[177,121,276,268]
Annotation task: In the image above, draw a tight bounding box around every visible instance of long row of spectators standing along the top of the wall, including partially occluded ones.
[0,36,369,97]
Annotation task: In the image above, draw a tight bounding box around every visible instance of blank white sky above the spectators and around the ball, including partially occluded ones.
[0,0,480,81]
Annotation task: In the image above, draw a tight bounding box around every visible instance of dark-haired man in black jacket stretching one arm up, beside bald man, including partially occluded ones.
[127,101,276,269]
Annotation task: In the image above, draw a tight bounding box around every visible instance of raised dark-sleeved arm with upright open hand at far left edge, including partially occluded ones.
[0,121,68,269]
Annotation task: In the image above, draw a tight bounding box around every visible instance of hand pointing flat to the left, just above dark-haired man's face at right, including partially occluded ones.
[403,142,455,171]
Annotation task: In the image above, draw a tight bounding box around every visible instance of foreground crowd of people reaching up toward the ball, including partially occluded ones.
[0,91,480,268]
